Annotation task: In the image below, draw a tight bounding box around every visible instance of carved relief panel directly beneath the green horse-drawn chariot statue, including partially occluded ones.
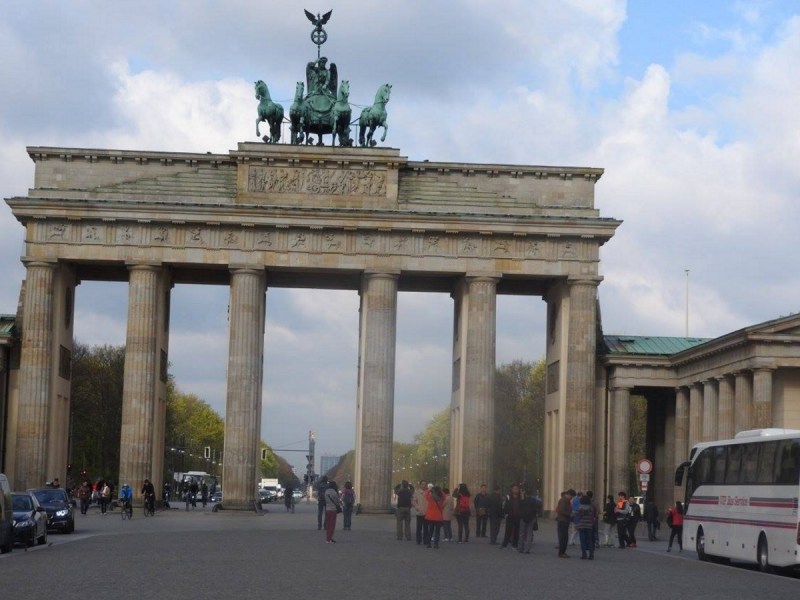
[247,166,386,197]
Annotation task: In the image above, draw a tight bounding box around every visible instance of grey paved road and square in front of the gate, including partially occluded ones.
[0,504,800,600]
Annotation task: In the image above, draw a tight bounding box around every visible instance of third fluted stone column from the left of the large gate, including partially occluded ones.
[222,267,266,510]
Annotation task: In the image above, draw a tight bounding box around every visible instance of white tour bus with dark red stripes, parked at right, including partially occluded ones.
[675,429,800,571]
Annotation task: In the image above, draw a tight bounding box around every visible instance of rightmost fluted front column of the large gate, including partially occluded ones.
[563,279,600,491]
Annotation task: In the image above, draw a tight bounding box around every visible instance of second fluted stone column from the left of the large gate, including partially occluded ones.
[119,265,162,497]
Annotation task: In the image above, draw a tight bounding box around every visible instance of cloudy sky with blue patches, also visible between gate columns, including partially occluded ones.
[0,0,800,462]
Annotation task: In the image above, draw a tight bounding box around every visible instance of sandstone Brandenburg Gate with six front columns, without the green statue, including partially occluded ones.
[1,143,620,511]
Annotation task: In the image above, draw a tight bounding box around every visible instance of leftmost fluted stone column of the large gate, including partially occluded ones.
[12,261,56,490]
